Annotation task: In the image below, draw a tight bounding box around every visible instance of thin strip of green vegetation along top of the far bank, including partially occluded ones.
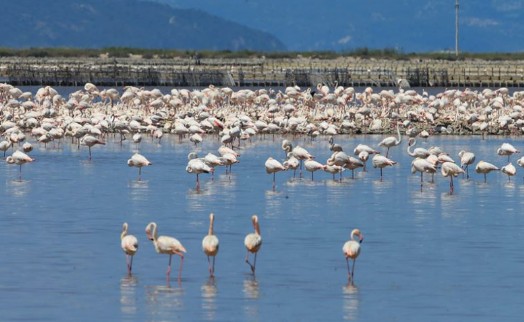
[0,47,524,61]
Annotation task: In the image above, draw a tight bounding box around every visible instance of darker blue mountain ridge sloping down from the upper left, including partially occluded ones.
[0,0,286,51]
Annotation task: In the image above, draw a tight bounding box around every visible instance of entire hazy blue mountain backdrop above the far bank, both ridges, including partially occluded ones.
[4,0,524,53]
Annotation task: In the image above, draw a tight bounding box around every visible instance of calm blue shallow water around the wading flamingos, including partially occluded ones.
[0,136,524,321]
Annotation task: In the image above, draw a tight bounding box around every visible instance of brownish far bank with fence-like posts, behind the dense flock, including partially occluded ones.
[0,57,524,88]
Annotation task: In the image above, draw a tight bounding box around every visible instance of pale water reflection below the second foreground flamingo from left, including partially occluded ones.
[146,281,184,321]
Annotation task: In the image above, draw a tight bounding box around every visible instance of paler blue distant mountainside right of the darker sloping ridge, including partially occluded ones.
[151,0,524,52]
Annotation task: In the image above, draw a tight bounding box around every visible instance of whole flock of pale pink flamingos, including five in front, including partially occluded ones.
[0,83,524,286]
